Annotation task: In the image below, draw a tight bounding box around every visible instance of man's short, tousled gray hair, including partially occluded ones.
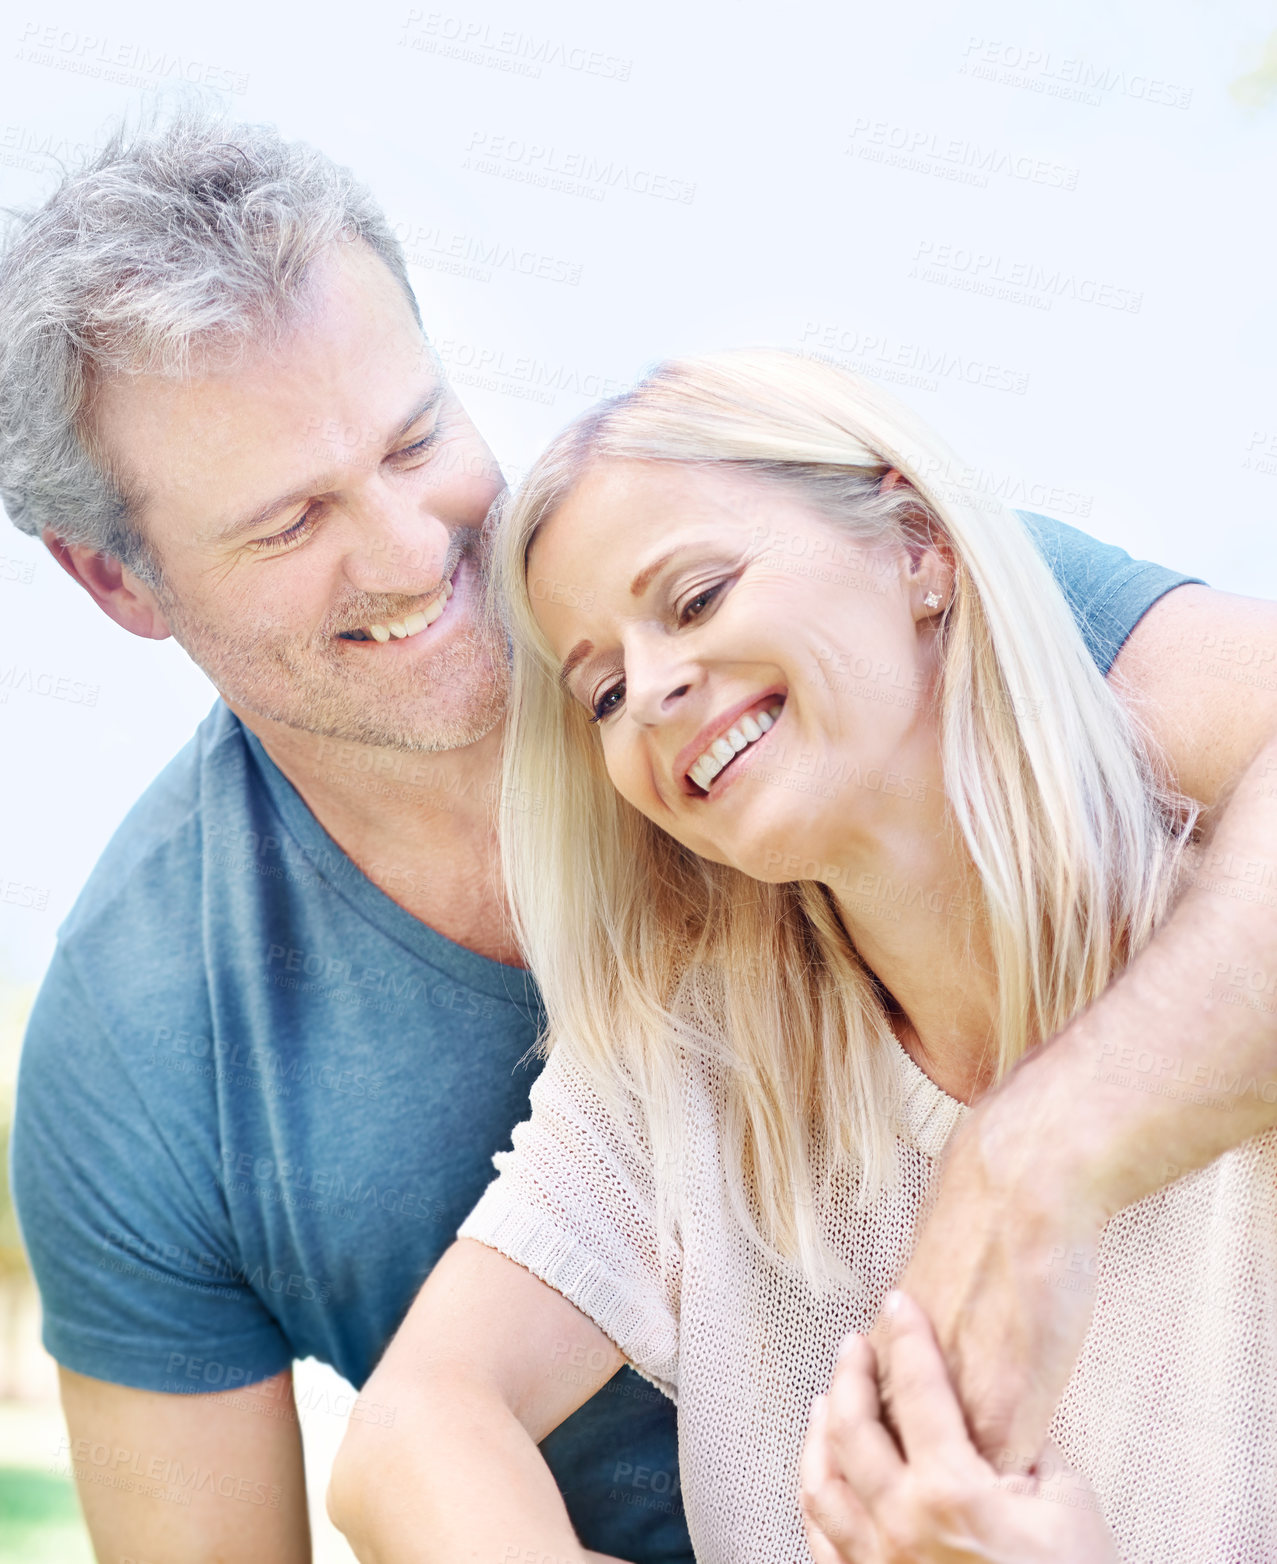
[0,103,421,583]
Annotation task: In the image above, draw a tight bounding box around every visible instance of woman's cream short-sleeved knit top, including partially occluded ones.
[460,1043,1277,1564]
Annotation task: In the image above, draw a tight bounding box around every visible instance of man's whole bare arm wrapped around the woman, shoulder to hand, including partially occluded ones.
[900,587,1277,1465]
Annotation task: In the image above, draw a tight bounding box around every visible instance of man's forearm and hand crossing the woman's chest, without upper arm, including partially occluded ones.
[900,741,1277,1465]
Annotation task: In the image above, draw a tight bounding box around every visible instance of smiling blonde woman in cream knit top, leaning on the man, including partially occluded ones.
[327,353,1277,1564]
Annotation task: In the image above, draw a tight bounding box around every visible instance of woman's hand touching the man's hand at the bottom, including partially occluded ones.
[801,1292,1117,1564]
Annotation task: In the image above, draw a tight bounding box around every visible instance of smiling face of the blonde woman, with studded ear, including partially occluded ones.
[527,460,951,881]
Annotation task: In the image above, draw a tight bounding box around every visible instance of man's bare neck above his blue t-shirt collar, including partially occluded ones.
[227,702,524,967]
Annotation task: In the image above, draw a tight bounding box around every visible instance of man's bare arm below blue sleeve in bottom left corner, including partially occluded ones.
[59,1369,310,1564]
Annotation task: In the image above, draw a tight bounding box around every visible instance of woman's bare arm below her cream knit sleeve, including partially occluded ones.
[329,1239,623,1564]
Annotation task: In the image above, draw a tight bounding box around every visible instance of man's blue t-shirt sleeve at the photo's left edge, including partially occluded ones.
[11,948,293,1392]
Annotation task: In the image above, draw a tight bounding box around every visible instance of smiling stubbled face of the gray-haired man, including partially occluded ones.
[89,244,507,749]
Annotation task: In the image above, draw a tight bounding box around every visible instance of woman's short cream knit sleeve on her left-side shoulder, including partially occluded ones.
[457,1043,681,1400]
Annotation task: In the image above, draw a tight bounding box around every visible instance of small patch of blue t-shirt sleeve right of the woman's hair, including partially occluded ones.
[1016,510,1207,674]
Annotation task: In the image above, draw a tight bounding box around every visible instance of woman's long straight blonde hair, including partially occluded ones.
[490,350,1196,1286]
